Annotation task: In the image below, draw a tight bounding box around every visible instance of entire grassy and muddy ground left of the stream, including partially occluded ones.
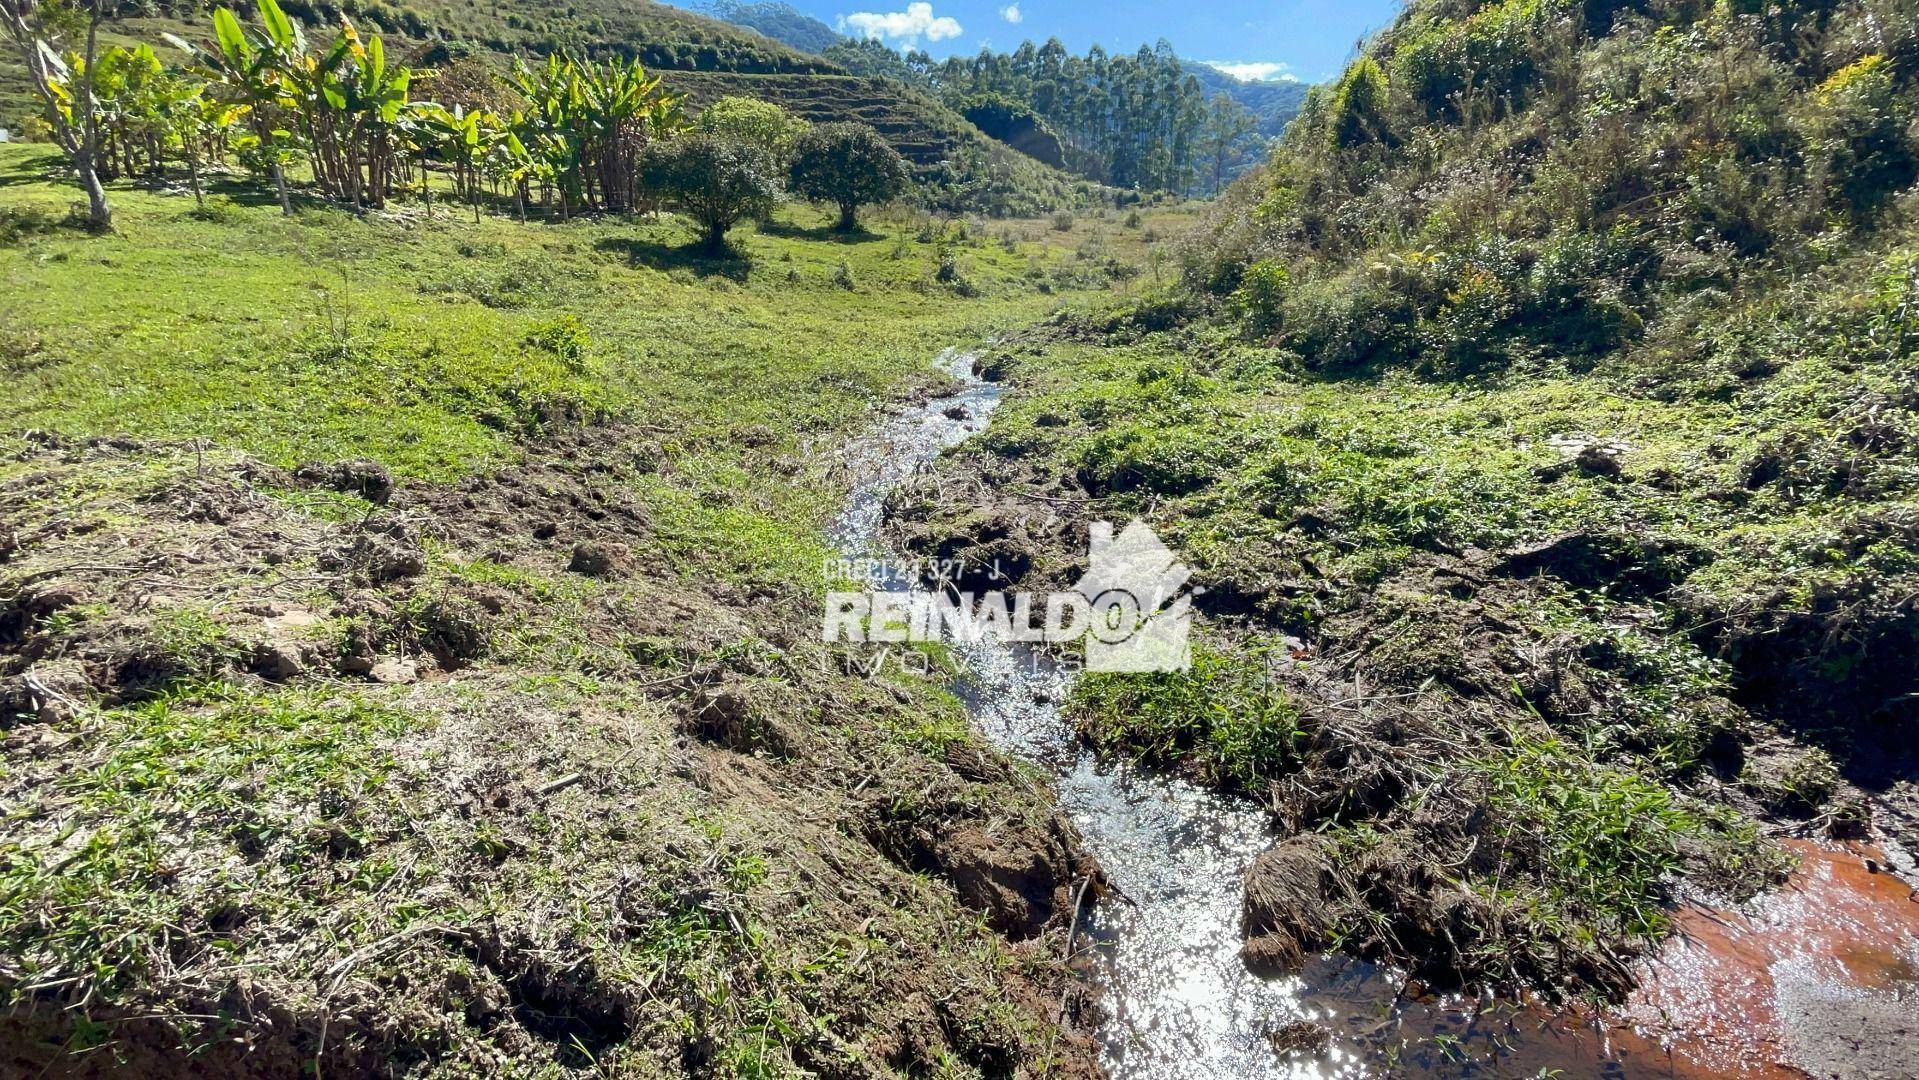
[0,146,1182,1076]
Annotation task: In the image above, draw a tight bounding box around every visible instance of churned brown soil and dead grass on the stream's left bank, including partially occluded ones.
[0,428,1098,1076]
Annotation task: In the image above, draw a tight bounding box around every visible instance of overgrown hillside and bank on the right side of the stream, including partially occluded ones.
[902,0,1919,994]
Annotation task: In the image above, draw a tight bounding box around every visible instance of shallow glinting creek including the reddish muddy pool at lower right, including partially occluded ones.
[835,351,1919,1080]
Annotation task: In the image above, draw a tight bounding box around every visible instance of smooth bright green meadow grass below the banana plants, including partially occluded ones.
[0,146,1136,480]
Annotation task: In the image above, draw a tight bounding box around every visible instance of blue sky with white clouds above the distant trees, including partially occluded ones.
[791,0,1399,82]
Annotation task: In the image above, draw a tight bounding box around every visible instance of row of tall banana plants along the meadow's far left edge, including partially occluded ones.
[39,0,685,217]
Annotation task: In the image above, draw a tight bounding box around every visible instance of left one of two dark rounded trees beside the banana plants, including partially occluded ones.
[639,134,779,251]
